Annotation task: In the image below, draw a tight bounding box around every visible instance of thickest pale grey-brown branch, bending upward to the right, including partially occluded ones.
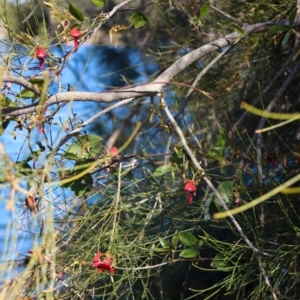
[2,19,300,117]
